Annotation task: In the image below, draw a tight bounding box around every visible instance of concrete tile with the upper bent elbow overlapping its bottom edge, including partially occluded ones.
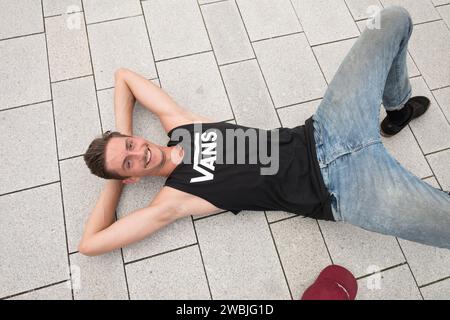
[88,16,157,90]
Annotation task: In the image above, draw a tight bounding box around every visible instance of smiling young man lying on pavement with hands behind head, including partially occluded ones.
[79,7,450,255]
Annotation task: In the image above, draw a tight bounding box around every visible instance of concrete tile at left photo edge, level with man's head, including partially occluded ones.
[0,102,59,194]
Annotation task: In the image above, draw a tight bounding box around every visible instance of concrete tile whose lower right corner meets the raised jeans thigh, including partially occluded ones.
[253,34,326,107]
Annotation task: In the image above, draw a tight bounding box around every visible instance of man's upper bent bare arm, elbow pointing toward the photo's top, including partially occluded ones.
[114,69,213,134]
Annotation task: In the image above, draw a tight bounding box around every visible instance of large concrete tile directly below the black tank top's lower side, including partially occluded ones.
[195,211,290,300]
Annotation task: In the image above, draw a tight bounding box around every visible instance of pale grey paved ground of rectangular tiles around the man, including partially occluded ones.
[0,0,450,299]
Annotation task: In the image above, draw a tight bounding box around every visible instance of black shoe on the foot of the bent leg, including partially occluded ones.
[380,96,430,137]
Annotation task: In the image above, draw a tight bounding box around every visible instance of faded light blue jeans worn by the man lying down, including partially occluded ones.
[313,6,450,249]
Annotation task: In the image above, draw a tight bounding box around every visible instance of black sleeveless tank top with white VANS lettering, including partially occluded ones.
[164,118,334,220]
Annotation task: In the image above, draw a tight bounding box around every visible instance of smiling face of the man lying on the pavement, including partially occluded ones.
[105,136,165,177]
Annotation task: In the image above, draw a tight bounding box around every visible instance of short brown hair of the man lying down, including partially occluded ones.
[84,131,129,180]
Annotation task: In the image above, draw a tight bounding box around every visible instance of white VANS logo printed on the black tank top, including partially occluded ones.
[190,132,217,183]
